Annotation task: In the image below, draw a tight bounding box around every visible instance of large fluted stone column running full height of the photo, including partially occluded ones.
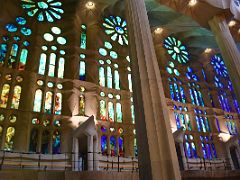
[126,0,181,180]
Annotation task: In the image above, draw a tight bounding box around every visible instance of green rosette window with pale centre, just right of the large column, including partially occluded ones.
[163,36,189,63]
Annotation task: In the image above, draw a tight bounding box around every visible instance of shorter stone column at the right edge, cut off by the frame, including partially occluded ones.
[209,16,240,102]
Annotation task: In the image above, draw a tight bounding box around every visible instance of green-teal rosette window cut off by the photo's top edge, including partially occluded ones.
[22,0,64,22]
